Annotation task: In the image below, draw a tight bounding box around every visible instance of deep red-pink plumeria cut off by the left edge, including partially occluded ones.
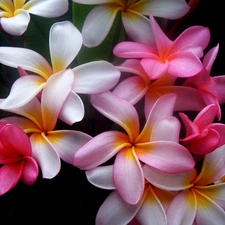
[0,122,39,195]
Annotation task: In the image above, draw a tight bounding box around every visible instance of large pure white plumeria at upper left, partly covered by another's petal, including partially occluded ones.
[0,21,120,124]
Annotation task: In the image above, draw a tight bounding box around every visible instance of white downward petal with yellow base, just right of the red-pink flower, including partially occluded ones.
[30,133,61,179]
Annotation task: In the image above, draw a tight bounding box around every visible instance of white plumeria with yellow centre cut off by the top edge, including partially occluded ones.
[73,0,189,47]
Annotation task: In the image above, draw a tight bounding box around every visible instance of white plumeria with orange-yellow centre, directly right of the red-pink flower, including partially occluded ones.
[1,69,91,178]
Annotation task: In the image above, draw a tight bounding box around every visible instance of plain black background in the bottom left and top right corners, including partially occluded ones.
[0,0,225,225]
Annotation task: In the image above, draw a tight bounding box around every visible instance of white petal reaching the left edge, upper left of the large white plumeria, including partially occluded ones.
[0,47,52,80]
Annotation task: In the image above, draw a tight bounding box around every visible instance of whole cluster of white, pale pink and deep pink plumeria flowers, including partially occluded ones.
[0,0,225,225]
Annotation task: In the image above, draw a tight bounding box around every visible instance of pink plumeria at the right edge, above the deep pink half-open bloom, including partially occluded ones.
[183,45,225,120]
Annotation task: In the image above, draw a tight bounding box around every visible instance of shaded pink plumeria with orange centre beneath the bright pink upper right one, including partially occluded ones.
[112,59,206,117]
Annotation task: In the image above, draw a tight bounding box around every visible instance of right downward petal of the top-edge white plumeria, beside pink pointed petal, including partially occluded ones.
[122,10,155,46]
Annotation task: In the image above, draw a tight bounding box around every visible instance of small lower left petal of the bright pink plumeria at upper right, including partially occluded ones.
[141,58,169,80]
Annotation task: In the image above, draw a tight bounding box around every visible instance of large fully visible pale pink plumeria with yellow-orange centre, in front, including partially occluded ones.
[73,92,195,204]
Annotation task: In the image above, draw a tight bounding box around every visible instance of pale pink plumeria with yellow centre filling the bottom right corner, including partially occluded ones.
[143,145,225,225]
